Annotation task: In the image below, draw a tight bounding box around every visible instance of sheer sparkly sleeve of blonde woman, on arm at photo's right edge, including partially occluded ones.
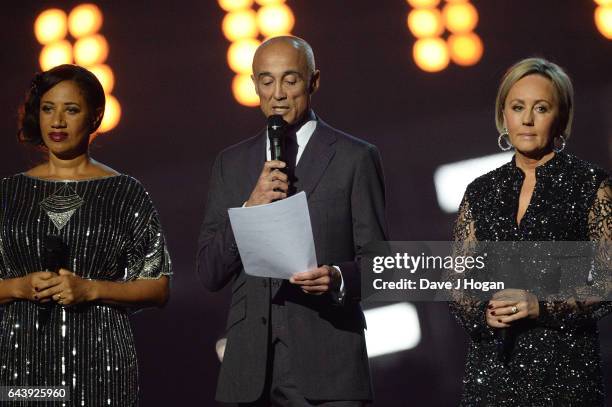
[539,178,612,327]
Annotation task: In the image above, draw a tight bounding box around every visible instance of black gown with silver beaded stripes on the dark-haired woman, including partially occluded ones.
[0,174,171,406]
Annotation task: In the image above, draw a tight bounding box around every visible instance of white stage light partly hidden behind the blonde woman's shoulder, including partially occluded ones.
[434,152,513,213]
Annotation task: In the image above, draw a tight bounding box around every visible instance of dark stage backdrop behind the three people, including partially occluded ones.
[0,0,612,406]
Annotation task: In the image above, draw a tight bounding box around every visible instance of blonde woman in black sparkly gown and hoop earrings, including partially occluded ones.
[451,58,612,407]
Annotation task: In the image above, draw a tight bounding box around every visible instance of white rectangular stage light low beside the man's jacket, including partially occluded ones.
[364,302,421,358]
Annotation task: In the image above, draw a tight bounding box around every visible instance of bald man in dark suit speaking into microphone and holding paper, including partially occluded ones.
[197,36,386,407]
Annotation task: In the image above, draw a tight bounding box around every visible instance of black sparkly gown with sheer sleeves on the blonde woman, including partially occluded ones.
[450,153,612,407]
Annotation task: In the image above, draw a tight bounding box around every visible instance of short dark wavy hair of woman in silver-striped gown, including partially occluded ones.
[17,64,106,146]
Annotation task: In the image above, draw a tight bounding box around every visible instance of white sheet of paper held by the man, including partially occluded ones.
[228,192,317,279]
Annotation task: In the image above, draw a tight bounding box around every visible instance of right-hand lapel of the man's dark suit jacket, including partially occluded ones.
[296,119,336,197]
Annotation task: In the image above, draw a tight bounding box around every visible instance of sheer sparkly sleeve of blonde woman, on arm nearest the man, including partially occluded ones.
[447,192,493,340]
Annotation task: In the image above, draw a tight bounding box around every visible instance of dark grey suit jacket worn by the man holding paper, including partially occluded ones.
[197,120,386,403]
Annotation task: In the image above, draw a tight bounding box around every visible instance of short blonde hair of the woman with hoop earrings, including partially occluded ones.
[495,58,574,140]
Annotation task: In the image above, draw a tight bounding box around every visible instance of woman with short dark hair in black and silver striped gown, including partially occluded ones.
[0,65,171,406]
